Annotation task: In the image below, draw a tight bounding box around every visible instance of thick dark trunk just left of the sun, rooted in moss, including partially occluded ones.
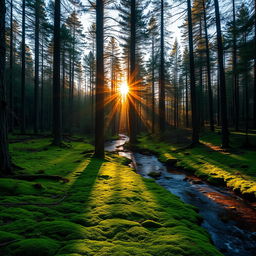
[95,0,105,158]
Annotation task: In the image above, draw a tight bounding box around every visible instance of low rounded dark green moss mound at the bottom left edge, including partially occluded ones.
[7,238,60,256]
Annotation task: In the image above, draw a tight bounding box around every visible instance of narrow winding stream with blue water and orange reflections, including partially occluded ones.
[105,134,256,256]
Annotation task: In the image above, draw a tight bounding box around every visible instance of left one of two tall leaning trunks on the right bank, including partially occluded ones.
[187,0,199,145]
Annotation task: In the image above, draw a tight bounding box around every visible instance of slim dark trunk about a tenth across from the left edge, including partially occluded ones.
[20,0,26,133]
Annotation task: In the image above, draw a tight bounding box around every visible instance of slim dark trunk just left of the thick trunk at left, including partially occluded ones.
[33,0,40,133]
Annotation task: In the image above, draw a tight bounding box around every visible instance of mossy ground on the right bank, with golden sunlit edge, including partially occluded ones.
[138,130,256,201]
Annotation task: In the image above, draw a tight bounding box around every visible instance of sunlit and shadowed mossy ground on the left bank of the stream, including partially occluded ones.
[0,138,221,256]
